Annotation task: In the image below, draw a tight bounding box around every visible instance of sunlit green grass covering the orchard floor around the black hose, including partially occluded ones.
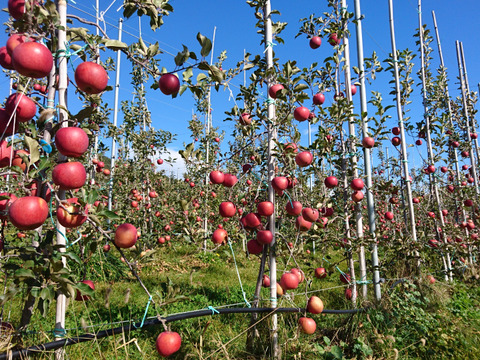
[0,243,480,360]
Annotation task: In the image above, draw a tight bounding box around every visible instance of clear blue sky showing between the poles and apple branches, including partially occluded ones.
[0,0,480,174]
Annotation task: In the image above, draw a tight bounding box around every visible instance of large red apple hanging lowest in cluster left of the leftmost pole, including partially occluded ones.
[8,196,48,230]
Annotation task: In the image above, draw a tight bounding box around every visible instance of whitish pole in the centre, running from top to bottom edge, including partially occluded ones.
[263,0,281,359]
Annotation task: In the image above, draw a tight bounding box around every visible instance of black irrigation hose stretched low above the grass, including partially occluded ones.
[0,308,364,360]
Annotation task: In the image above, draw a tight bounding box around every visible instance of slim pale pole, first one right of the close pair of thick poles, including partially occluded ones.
[388,0,420,267]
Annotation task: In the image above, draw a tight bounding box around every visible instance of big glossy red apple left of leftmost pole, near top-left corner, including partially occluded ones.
[12,41,53,79]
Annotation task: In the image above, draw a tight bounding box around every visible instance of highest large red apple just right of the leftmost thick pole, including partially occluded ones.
[75,61,108,94]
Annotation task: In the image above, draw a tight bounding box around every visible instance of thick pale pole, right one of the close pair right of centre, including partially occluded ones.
[355,0,378,300]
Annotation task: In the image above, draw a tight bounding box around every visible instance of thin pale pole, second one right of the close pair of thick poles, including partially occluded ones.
[418,0,452,281]
